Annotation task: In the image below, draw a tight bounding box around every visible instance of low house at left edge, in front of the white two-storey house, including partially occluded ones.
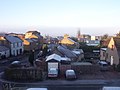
[0,46,10,59]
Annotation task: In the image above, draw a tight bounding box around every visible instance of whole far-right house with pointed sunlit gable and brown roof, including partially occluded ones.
[106,37,120,65]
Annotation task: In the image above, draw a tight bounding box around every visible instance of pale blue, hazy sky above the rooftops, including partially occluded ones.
[0,0,120,36]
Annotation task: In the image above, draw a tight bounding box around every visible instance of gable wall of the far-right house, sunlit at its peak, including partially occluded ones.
[106,38,119,65]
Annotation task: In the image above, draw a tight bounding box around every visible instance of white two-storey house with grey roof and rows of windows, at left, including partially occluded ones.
[0,35,24,56]
